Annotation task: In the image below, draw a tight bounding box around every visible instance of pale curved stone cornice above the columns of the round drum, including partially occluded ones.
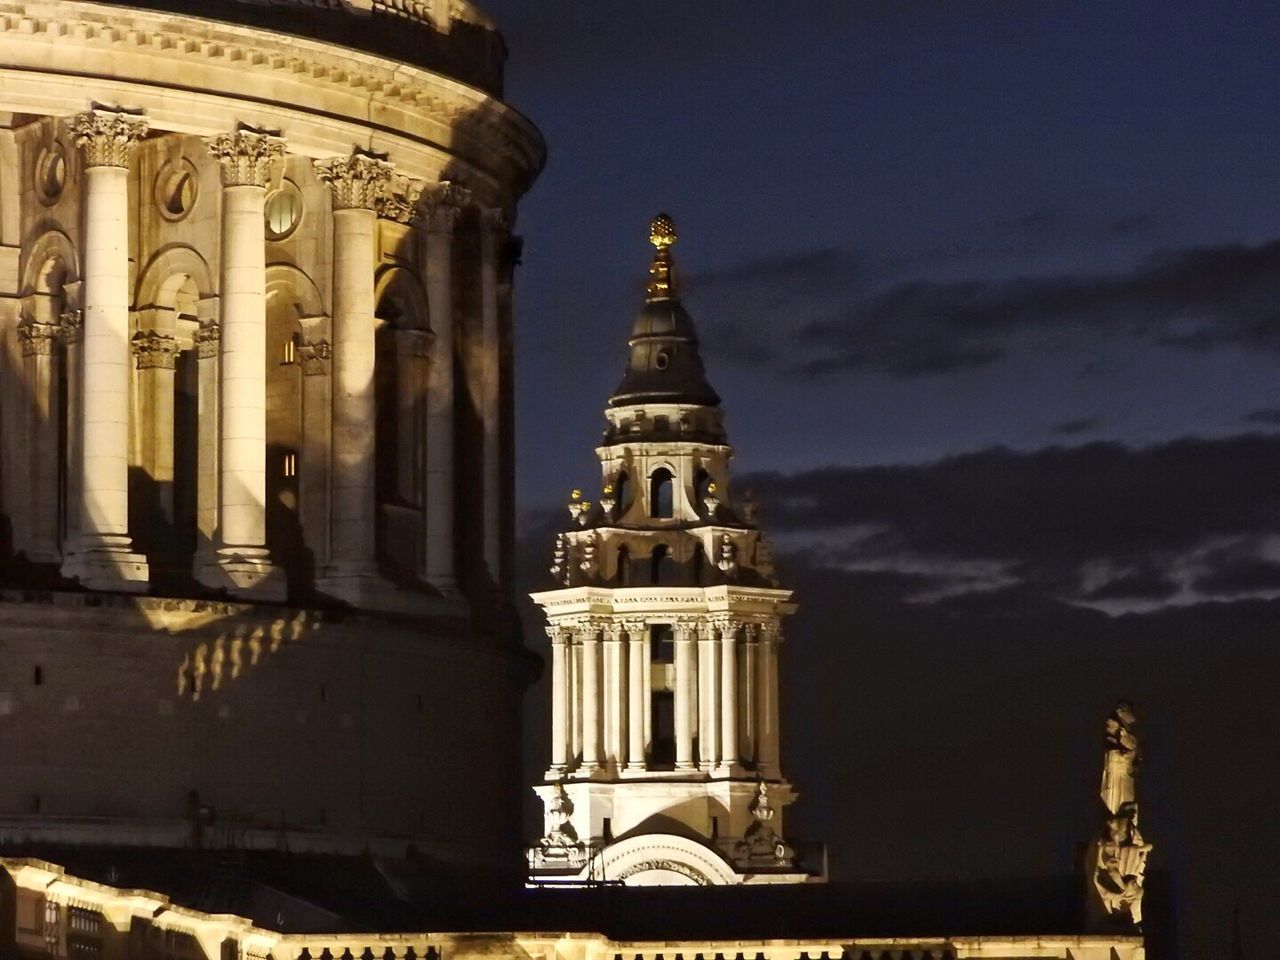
[0,0,544,202]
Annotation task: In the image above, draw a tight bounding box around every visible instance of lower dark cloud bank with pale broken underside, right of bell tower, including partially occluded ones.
[742,434,1280,602]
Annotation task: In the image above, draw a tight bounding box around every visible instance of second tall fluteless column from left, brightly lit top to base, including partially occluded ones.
[206,125,285,599]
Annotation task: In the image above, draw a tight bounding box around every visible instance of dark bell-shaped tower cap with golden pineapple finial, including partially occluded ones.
[609,214,719,407]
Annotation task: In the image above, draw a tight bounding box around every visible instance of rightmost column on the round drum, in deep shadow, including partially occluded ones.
[472,210,511,584]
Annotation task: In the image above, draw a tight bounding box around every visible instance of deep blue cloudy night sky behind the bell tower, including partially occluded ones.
[485,0,1280,960]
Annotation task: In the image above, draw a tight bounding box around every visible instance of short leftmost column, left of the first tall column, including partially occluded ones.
[18,316,61,563]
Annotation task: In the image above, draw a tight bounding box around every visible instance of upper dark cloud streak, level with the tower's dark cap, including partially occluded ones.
[690,236,1280,378]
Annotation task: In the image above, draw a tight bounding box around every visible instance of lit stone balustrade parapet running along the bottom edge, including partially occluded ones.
[0,860,1146,960]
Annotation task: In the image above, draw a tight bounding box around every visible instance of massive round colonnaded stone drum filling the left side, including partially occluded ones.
[0,0,543,869]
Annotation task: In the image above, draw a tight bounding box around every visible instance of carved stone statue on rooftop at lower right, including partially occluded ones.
[1091,700,1151,925]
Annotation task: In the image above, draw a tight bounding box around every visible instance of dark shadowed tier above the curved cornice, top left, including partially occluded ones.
[102,0,507,96]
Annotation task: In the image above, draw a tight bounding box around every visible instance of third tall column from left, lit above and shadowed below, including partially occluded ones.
[316,151,394,605]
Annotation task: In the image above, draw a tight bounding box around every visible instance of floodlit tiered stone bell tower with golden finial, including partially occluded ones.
[529,215,817,886]
